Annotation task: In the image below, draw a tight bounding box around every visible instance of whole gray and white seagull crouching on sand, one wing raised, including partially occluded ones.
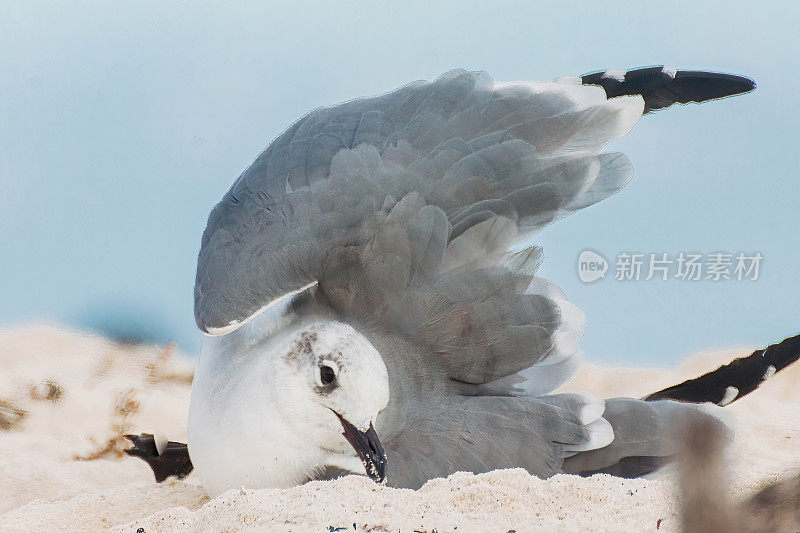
[129,66,800,496]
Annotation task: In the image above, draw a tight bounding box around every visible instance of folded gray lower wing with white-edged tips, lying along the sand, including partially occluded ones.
[377,395,602,488]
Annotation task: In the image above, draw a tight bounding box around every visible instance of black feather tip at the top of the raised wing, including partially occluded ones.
[581,66,756,113]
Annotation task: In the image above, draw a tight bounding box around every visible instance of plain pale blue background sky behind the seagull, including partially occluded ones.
[0,1,800,365]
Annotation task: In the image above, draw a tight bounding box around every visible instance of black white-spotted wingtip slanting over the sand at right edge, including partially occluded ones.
[644,335,800,405]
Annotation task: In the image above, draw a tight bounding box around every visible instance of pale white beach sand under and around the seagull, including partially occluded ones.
[0,326,800,533]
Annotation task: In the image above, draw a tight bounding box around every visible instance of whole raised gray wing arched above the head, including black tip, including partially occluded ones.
[195,68,754,386]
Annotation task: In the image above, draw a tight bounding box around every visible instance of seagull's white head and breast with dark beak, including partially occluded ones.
[188,306,389,495]
